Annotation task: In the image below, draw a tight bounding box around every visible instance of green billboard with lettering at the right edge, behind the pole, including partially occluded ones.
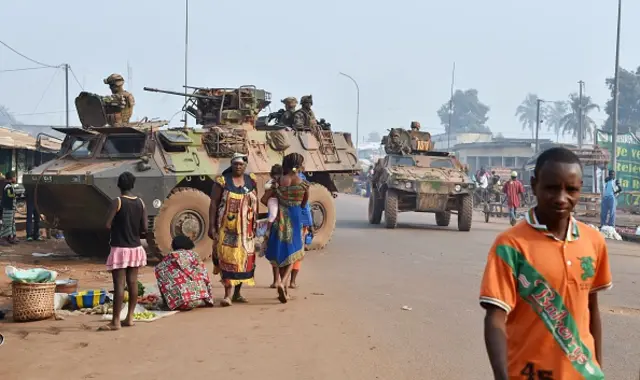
[596,130,640,208]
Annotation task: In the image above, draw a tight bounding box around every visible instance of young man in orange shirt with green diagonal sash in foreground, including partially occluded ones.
[480,148,611,380]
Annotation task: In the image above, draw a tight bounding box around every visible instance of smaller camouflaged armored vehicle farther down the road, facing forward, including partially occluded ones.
[369,128,475,231]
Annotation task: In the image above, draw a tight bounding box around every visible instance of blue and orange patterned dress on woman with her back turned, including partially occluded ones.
[266,181,309,267]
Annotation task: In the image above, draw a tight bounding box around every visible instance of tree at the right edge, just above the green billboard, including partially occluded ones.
[603,67,640,133]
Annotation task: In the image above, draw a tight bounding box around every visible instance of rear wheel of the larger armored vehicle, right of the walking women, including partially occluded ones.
[307,183,336,251]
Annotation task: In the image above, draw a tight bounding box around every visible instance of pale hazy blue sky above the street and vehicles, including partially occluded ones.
[0,0,640,144]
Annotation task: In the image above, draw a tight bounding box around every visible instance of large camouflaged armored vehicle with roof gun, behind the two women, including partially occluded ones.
[23,86,357,257]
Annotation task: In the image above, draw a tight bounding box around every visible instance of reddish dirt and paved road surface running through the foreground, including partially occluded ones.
[0,196,640,380]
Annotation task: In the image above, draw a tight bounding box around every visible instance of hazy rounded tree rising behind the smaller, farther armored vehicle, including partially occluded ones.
[438,89,491,133]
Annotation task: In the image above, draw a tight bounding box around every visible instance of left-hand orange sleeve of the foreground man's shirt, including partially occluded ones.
[480,236,518,313]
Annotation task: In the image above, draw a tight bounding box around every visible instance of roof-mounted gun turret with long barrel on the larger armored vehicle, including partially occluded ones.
[144,86,271,128]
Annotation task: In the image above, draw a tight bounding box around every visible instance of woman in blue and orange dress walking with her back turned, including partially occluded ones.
[265,153,309,303]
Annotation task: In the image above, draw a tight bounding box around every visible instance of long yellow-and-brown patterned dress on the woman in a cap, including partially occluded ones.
[213,173,258,286]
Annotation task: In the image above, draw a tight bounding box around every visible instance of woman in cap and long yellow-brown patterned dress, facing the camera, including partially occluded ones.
[209,153,258,306]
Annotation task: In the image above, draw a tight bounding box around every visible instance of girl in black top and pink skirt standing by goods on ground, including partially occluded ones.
[98,172,147,331]
